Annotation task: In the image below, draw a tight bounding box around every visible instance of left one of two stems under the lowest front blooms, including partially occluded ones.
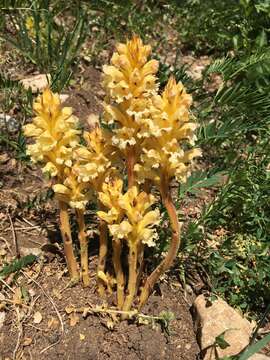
[112,239,125,310]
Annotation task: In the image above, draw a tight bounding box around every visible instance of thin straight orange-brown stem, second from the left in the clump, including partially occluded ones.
[76,210,90,287]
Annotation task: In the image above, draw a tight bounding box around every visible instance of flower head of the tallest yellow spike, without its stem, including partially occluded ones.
[103,36,158,153]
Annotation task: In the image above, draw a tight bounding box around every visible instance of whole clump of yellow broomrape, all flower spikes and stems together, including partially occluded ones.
[24,36,201,318]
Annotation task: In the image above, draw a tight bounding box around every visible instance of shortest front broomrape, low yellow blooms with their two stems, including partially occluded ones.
[98,179,160,311]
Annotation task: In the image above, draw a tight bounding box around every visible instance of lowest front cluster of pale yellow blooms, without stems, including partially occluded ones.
[98,179,160,246]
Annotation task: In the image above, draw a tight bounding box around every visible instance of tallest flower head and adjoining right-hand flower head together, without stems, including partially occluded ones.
[103,36,200,187]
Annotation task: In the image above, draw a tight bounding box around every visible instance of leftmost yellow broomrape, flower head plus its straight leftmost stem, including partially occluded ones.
[24,88,80,282]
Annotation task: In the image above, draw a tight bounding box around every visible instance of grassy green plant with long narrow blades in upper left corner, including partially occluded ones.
[0,0,86,90]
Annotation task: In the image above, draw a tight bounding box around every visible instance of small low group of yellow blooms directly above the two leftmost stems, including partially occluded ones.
[53,168,91,210]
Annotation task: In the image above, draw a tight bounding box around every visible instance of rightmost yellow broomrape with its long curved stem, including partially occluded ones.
[134,77,201,307]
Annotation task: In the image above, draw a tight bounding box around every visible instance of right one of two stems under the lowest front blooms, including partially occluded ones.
[123,244,138,319]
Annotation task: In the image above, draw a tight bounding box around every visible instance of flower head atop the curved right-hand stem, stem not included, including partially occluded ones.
[134,77,201,182]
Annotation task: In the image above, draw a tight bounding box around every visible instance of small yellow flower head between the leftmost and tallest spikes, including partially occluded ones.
[73,127,115,190]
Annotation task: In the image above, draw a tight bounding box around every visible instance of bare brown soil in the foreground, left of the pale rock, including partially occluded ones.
[0,261,198,360]
